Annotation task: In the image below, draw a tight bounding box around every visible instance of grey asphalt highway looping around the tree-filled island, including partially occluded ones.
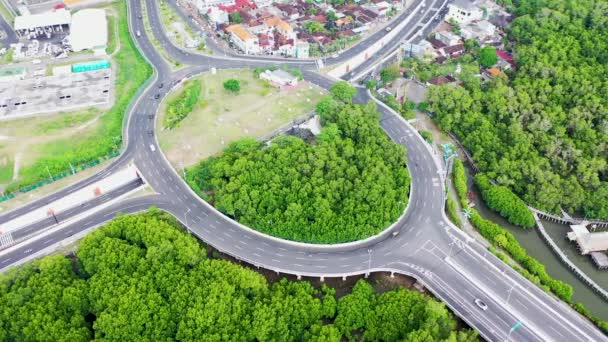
[0,0,608,341]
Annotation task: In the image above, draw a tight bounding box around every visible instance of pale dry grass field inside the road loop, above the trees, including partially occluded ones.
[156,69,325,168]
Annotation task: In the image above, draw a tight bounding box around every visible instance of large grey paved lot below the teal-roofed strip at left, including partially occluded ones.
[0,69,114,120]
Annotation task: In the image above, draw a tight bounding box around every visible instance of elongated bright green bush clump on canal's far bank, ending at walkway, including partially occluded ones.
[475,173,536,228]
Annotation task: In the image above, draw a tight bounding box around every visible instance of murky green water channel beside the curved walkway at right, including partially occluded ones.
[467,168,608,320]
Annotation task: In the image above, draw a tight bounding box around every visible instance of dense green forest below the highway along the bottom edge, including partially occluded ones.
[0,210,477,342]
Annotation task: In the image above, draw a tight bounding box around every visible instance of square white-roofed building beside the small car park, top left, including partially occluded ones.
[69,8,108,54]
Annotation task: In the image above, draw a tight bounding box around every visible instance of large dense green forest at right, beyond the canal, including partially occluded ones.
[429,0,608,219]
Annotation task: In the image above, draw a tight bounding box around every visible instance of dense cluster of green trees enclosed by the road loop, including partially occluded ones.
[188,82,410,243]
